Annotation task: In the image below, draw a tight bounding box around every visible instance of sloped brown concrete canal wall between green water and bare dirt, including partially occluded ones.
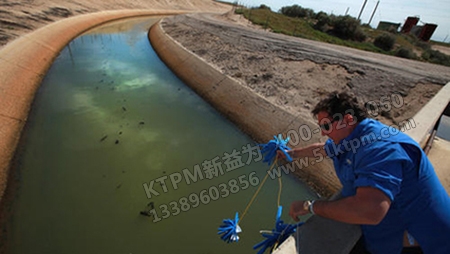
[149,21,341,197]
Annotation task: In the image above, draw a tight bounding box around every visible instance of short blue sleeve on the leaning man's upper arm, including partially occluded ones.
[354,142,409,201]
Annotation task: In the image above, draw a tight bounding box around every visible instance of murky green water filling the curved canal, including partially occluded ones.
[7,16,314,254]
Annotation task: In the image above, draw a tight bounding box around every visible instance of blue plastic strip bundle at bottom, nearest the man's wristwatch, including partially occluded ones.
[253,206,303,254]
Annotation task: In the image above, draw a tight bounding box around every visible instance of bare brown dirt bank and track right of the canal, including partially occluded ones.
[163,13,450,129]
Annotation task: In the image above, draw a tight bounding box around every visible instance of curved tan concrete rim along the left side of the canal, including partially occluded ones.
[0,10,192,204]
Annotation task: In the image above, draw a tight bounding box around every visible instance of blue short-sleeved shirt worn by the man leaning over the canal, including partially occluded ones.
[325,119,450,254]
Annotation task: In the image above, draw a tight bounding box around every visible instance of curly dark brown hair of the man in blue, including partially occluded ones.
[312,91,368,122]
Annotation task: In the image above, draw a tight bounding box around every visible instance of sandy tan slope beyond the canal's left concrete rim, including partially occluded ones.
[0,0,230,49]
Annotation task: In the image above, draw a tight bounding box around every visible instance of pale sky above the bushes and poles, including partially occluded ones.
[226,0,450,42]
